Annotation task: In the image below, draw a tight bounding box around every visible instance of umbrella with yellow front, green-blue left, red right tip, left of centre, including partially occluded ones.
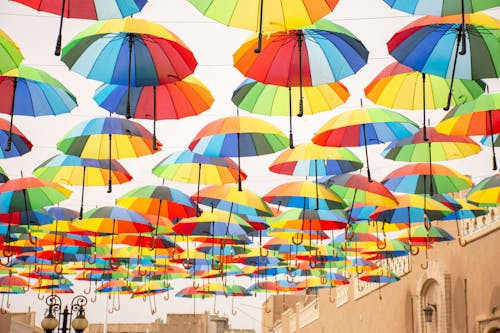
[33,154,132,218]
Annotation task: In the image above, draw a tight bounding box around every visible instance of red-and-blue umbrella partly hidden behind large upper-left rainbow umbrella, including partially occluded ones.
[94,76,214,149]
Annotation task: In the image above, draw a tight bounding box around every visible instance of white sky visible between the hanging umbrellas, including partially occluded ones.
[0,0,500,332]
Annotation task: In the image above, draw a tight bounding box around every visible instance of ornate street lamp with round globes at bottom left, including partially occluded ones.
[41,295,89,333]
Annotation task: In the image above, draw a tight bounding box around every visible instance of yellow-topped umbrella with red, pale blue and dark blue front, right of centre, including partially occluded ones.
[269,143,363,181]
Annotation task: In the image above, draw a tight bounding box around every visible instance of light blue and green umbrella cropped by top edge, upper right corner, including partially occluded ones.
[384,0,498,16]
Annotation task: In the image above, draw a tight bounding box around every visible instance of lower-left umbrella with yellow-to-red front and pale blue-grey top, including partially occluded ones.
[73,206,153,268]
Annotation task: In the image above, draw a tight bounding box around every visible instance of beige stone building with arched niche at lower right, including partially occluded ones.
[262,208,500,333]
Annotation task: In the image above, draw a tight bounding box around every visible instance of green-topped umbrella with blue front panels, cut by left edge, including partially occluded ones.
[0,65,77,150]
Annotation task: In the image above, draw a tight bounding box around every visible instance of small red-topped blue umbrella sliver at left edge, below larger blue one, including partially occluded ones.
[0,118,33,159]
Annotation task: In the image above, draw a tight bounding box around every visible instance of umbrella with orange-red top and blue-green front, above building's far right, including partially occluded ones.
[381,163,472,196]
